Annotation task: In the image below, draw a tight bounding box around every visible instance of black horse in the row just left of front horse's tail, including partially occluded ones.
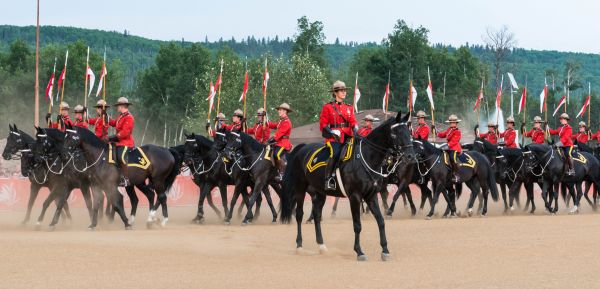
[225,131,280,225]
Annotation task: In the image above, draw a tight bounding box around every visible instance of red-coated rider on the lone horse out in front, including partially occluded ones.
[319,80,357,190]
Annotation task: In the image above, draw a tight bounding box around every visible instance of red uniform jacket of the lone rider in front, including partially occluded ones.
[319,101,356,142]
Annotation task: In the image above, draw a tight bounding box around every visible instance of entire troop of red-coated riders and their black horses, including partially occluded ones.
[3,81,600,260]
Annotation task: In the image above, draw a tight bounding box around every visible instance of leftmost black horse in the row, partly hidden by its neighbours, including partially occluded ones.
[2,124,71,225]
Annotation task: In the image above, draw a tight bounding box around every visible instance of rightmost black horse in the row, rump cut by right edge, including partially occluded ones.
[523,144,600,214]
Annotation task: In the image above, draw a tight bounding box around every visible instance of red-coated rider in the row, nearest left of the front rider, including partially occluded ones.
[267,103,293,181]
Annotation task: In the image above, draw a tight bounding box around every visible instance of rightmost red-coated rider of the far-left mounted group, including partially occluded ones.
[108,97,135,186]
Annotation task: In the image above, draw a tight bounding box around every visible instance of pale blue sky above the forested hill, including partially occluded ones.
[0,0,600,53]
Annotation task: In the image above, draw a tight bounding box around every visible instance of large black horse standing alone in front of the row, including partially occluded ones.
[281,113,414,261]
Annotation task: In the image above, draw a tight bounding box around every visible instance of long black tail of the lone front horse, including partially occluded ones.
[279,144,305,224]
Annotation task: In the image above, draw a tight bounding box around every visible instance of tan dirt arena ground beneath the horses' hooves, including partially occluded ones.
[0,194,600,288]
